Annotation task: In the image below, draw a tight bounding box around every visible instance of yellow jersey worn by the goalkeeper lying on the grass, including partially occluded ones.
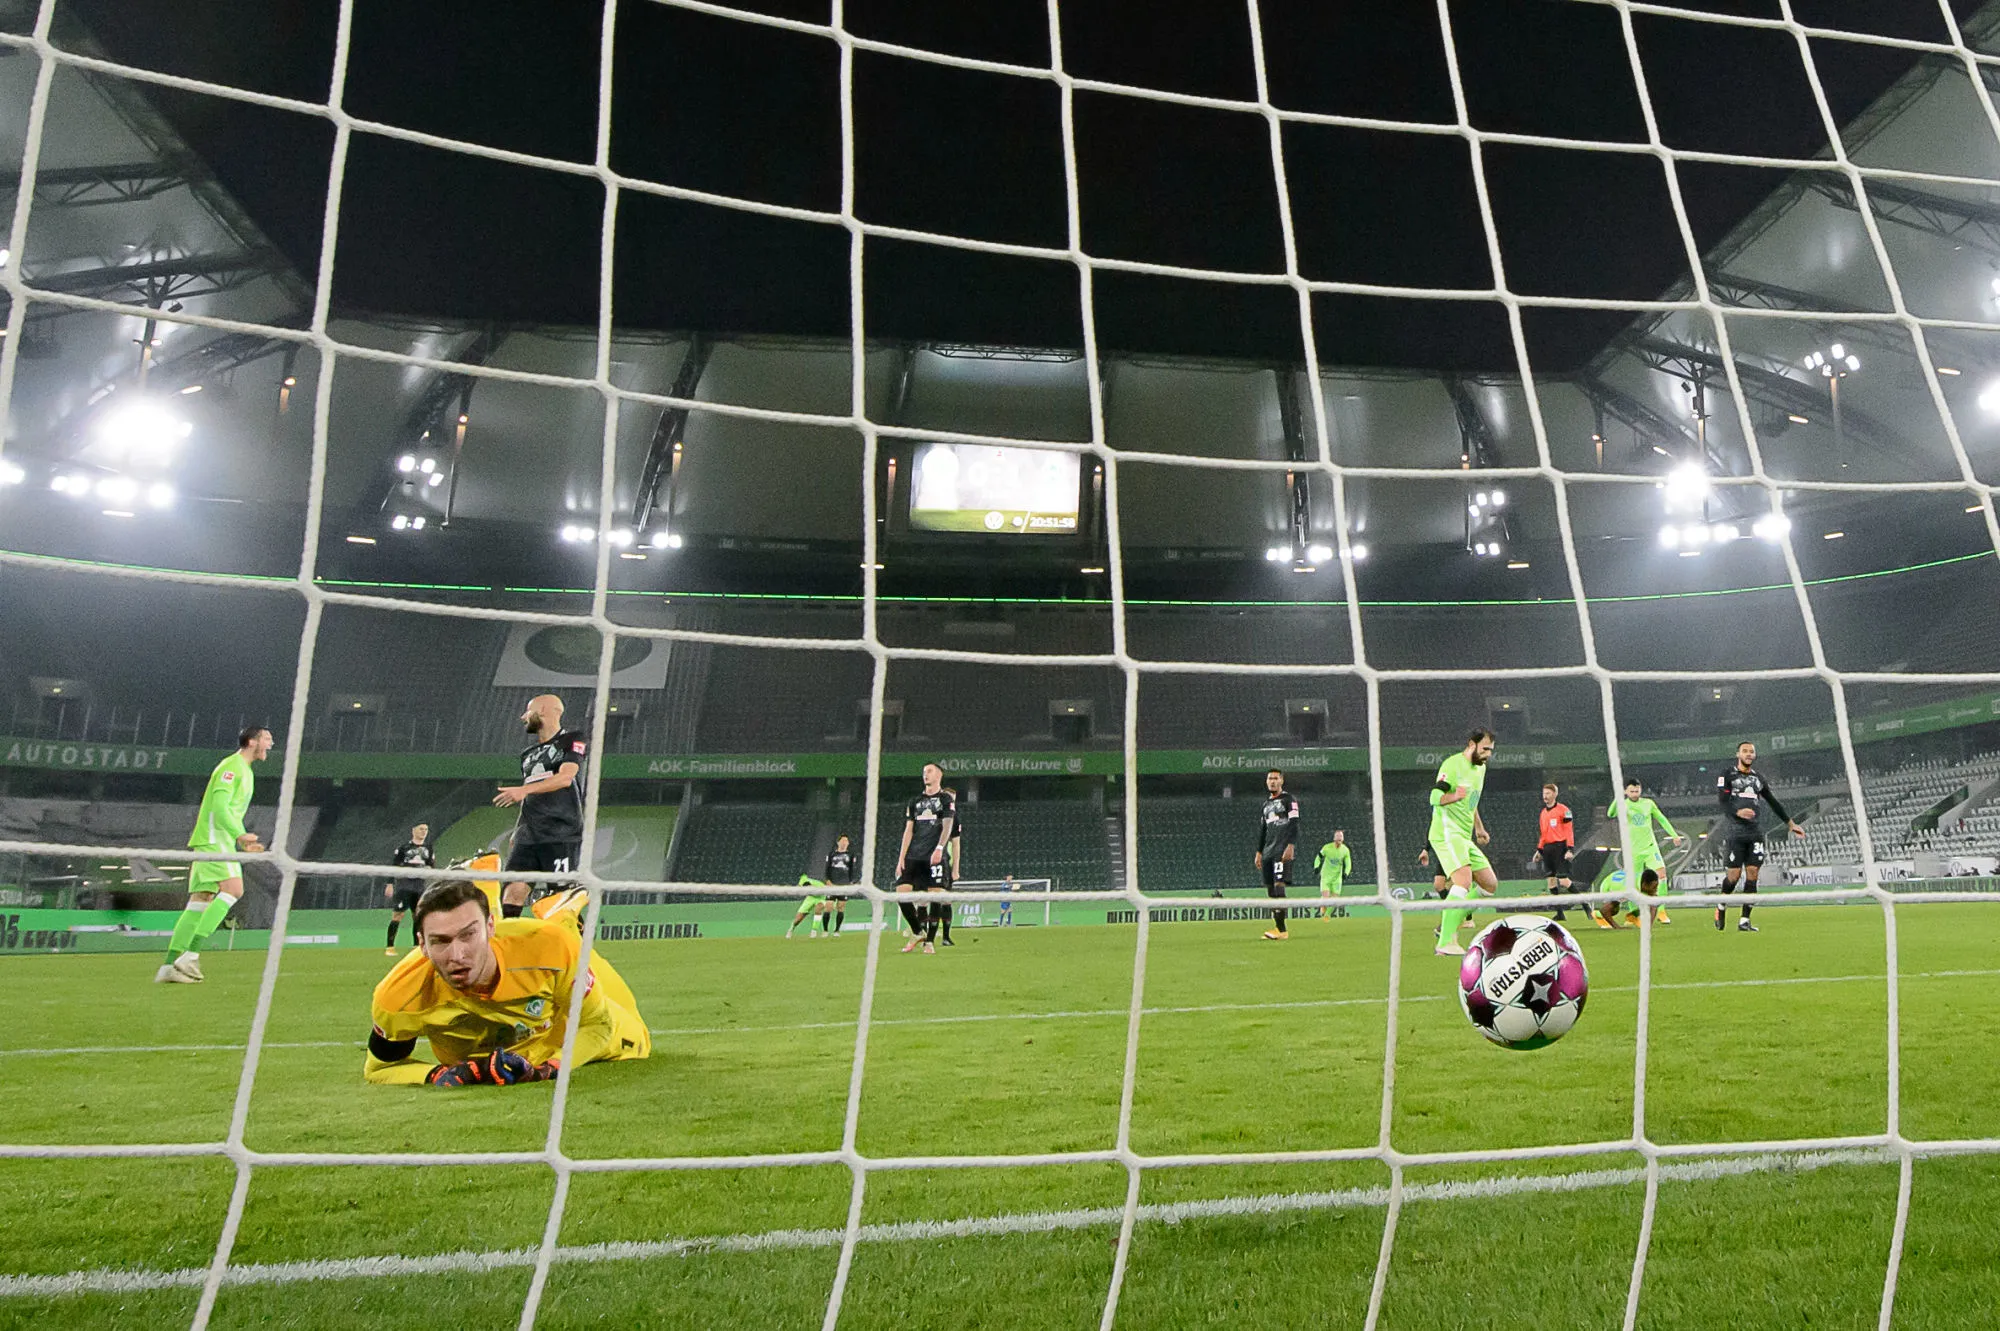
[366,913,652,1083]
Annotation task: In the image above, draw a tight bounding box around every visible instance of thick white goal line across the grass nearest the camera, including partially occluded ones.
[0,1151,1896,1299]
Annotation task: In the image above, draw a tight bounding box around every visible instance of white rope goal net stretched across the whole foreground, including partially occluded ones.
[0,0,2000,1331]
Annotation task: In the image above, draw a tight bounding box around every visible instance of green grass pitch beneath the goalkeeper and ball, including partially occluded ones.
[0,903,2000,1331]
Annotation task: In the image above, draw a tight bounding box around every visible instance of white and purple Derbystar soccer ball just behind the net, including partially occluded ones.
[1458,915,1590,1049]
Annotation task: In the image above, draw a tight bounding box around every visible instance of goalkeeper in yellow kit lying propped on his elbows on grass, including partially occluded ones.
[366,881,652,1085]
